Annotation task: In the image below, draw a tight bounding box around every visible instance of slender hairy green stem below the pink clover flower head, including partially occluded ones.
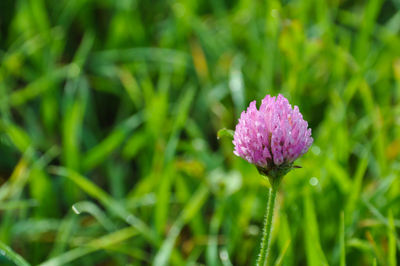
[257,184,278,266]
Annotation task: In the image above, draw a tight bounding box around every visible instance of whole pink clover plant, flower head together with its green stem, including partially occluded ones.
[220,94,313,265]
